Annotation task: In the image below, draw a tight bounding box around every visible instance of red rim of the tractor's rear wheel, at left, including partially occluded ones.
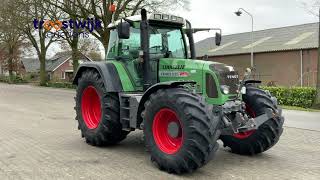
[81,86,101,129]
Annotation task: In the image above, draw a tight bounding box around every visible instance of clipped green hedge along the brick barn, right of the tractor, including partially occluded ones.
[261,87,316,108]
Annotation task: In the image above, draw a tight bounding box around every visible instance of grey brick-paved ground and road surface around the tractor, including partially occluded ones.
[0,83,320,180]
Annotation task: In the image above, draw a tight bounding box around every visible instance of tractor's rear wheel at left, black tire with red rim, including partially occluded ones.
[75,70,129,146]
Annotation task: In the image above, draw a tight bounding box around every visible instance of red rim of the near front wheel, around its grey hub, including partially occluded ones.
[152,108,183,154]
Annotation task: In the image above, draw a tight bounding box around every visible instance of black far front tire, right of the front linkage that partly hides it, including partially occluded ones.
[220,85,284,155]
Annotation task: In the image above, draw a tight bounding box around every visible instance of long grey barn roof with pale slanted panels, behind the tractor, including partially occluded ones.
[195,23,319,57]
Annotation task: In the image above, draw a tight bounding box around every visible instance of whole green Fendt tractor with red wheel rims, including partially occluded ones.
[73,9,284,174]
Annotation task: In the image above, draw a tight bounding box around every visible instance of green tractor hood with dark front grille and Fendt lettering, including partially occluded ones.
[158,58,239,102]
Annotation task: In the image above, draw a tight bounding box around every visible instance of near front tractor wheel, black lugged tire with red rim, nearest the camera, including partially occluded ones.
[142,88,220,174]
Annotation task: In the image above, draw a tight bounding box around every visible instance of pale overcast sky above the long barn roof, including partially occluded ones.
[176,0,318,41]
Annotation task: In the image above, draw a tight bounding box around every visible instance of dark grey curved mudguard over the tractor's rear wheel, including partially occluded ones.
[73,62,123,92]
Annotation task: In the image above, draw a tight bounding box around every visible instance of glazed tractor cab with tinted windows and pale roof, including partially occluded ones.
[106,14,188,90]
